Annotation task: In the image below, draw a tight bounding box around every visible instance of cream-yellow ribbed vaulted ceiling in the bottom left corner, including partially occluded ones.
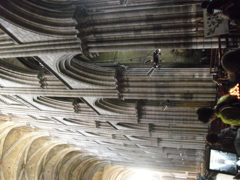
[0,121,107,180]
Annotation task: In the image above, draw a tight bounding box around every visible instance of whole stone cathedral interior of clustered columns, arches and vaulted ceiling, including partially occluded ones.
[0,0,217,180]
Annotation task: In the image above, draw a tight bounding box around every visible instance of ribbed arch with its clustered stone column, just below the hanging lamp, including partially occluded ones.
[58,55,215,100]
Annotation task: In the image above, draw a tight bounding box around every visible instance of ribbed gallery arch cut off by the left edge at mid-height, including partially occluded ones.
[0,58,65,89]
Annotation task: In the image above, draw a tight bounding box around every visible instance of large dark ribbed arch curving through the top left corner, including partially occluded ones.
[0,0,77,37]
